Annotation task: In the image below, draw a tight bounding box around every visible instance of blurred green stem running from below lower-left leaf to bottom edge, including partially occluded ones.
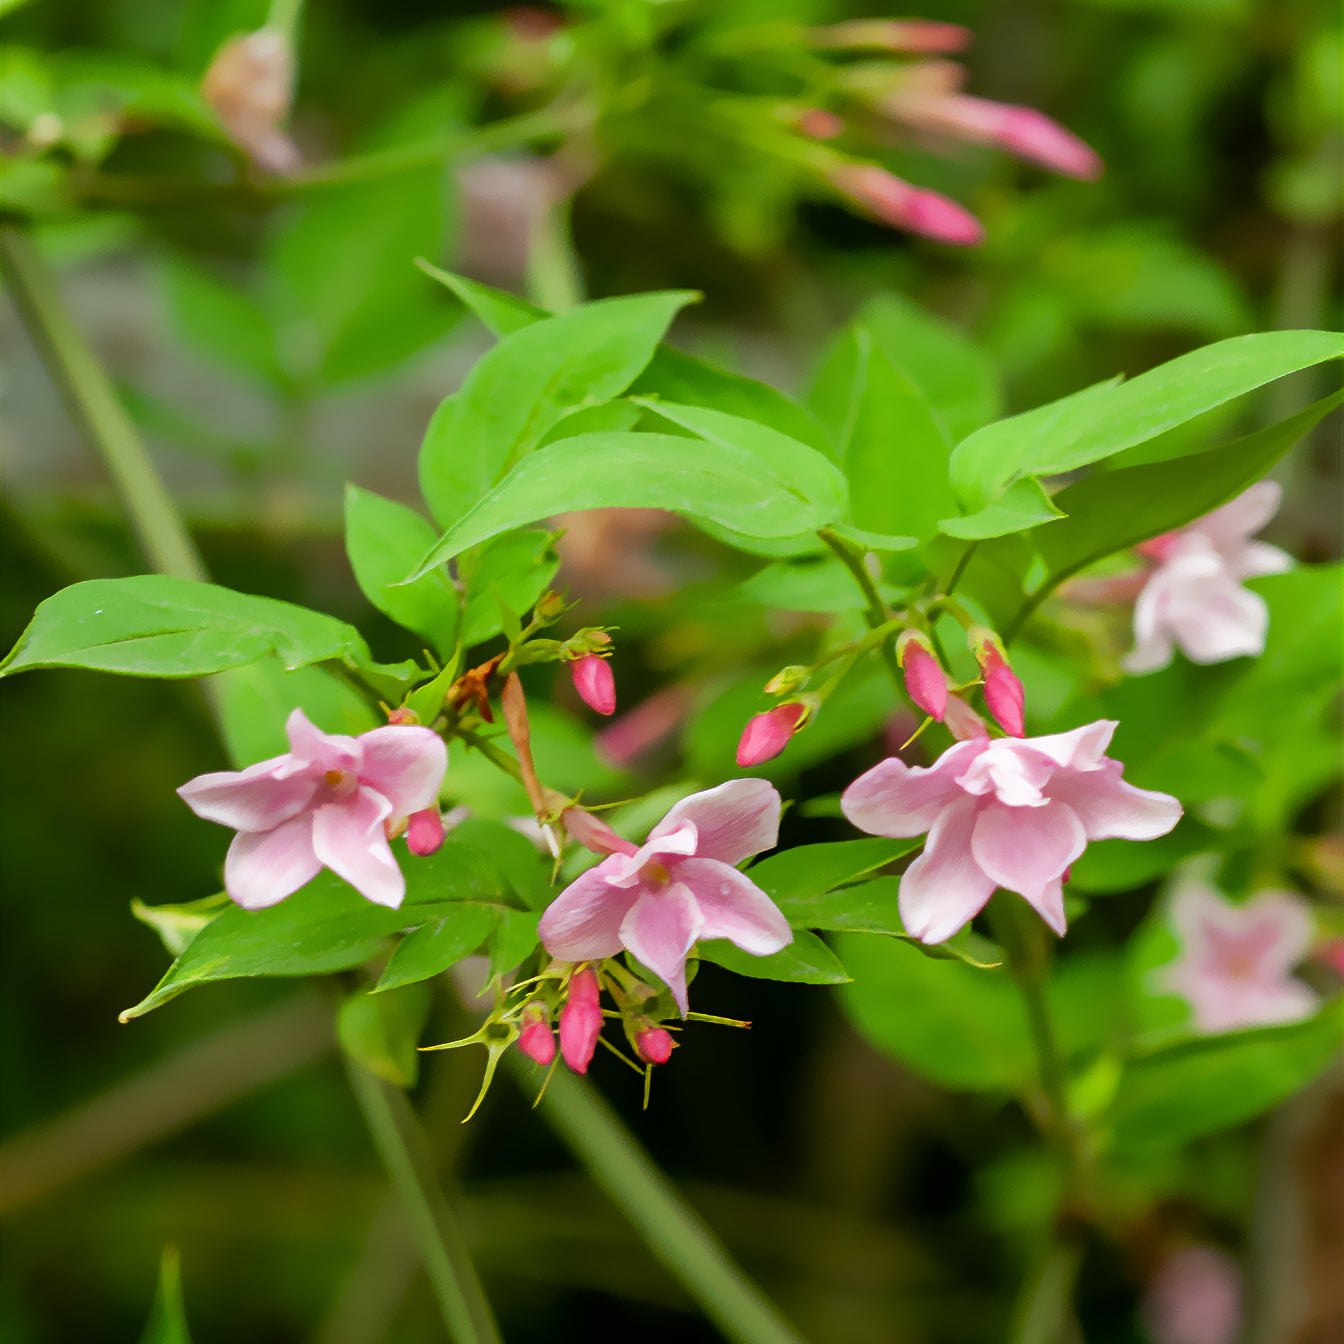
[345,1056,501,1344]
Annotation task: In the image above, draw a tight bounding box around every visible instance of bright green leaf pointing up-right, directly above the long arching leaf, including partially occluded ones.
[419,290,696,526]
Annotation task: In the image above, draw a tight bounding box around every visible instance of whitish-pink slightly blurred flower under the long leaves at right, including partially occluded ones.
[1124,481,1293,672]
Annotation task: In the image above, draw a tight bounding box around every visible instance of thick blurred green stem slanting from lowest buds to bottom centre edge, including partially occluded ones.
[524,1060,802,1344]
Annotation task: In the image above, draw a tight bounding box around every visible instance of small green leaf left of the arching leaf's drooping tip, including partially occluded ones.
[345,485,457,653]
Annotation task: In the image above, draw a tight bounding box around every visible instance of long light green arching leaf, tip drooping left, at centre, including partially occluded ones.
[410,433,825,579]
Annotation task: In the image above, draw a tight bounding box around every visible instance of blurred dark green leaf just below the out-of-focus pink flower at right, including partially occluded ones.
[1111,1000,1344,1148]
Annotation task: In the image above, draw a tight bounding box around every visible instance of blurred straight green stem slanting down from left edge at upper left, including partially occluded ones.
[0,224,206,581]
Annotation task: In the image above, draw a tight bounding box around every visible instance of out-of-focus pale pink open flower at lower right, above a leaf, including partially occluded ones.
[1159,883,1320,1032]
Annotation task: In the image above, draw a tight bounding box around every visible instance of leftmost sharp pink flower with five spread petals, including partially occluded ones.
[177,710,448,910]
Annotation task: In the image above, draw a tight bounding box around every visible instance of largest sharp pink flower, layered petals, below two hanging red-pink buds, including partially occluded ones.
[840,720,1181,942]
